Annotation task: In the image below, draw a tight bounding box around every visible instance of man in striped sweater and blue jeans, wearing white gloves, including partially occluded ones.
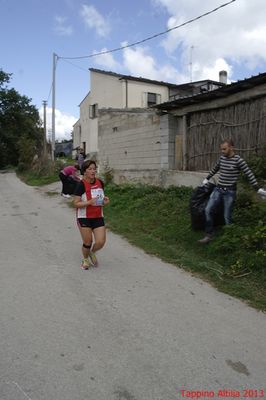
[198,139,265,244]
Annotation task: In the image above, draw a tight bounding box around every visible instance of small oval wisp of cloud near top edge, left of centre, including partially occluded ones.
[80,4,111,37]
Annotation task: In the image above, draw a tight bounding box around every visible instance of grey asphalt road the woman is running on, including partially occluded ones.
[0,173,266,400]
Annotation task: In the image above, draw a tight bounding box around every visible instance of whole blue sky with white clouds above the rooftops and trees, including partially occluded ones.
[0,0,266,140]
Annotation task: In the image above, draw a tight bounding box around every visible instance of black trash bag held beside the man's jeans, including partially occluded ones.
[189,182,224,230]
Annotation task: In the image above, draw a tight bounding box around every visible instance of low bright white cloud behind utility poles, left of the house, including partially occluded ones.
[39,107,77,141]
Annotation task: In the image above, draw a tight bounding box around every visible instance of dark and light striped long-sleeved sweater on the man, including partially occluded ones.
[207,154,258,189]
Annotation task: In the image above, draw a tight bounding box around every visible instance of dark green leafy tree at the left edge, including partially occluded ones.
[0,70,43,168]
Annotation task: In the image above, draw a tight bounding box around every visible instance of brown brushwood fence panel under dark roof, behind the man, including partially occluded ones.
[186,97,266,171]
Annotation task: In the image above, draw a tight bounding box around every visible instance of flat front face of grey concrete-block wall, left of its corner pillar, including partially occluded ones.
[98,109,161,171]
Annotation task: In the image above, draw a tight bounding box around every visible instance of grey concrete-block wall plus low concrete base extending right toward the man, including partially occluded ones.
[97,109,213,187]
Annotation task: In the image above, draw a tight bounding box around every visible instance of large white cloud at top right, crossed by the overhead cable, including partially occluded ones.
[153,0,266,80]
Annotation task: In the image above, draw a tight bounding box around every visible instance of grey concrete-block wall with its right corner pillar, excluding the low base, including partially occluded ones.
[98,109,178,171]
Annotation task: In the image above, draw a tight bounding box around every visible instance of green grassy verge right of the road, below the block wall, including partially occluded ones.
[105,185,266,311]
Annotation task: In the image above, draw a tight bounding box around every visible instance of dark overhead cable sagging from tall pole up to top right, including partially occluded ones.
[58,0,236,60]
